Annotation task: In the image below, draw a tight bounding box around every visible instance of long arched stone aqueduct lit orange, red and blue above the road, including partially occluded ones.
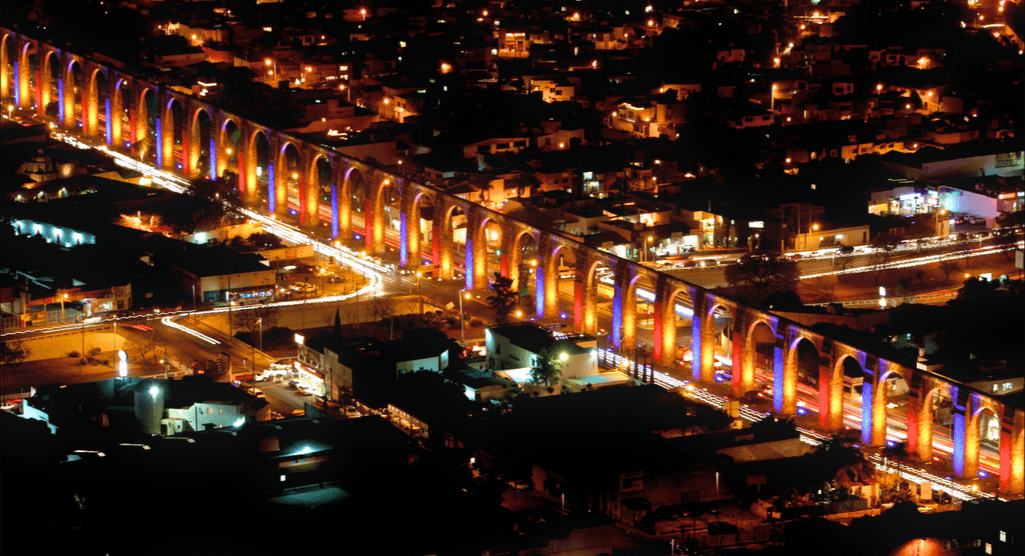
[0,29,1023,493]
